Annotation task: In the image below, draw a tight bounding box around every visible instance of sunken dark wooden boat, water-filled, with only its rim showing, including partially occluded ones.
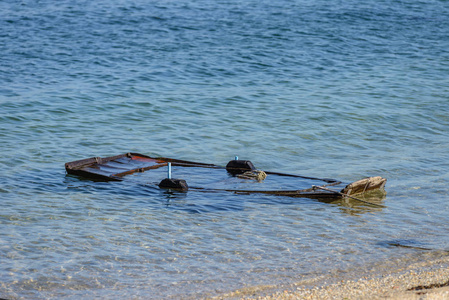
[65,153,387,206]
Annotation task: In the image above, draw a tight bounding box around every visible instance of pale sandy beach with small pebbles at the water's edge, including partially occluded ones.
[215,257,449,300]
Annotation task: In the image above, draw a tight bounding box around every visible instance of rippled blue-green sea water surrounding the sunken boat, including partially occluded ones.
[0,0,449,299]
